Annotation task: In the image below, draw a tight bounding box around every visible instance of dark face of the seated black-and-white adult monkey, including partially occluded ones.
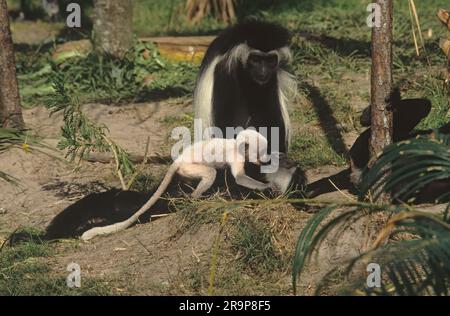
[247,51,278,85]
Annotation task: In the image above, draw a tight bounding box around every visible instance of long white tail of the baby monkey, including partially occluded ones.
[81,162,179,241]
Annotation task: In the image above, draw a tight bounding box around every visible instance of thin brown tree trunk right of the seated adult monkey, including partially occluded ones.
[369,0,393,200]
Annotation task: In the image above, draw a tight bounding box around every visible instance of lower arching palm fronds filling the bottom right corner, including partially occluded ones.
[292,204,450,295]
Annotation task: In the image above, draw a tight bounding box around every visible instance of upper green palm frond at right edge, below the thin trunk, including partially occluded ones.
[361,132,450,201]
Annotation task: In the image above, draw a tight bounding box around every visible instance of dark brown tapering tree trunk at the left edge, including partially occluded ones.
[0,0,25,129]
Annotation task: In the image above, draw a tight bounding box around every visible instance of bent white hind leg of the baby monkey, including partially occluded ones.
[178,164,217,199]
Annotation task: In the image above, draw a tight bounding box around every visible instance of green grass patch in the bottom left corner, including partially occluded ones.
[0,229,112,296]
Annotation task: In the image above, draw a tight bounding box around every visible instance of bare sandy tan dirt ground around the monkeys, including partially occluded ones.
[0,95,372,294]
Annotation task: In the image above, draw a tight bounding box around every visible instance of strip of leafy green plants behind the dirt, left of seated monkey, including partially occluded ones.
[16,43,198,107]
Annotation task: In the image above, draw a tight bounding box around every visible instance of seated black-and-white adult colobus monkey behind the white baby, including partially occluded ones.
[194,21,296,153]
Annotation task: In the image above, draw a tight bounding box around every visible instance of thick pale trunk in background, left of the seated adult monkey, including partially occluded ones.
[94,0,134,58]
